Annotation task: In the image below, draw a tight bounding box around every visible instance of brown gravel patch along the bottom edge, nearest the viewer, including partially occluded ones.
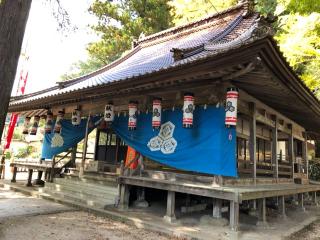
[0,212,181,240]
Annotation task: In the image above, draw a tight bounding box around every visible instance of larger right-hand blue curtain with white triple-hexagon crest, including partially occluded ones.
[112,107,237,177]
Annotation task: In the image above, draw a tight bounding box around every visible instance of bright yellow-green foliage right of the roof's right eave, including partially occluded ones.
[275,13,320,95]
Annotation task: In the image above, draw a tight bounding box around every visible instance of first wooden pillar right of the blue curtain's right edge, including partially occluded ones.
[249,102,257,184]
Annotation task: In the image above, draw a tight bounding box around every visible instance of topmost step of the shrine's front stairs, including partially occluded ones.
[54,178,118,192]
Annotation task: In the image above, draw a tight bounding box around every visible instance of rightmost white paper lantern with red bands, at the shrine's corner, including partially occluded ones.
[225,87,239,126]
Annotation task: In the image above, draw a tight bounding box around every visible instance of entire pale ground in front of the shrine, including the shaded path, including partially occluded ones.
[0,188,175,240]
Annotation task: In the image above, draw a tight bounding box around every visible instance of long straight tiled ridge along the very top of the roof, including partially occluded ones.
[136,3,245,45]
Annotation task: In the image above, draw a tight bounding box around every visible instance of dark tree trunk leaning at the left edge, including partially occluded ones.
[0,0,32,139]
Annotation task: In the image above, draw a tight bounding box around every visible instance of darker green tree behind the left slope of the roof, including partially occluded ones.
[88,0,173,64]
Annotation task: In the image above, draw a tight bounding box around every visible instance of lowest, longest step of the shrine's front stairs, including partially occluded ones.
[41,188,115,209]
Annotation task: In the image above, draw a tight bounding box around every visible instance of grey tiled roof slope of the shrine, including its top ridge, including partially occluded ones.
[10,2,258,106]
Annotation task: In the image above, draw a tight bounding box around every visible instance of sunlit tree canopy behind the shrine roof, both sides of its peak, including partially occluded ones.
[64,0,320,98]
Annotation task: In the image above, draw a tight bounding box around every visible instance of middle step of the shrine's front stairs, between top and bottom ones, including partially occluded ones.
[45,183,118,199]
